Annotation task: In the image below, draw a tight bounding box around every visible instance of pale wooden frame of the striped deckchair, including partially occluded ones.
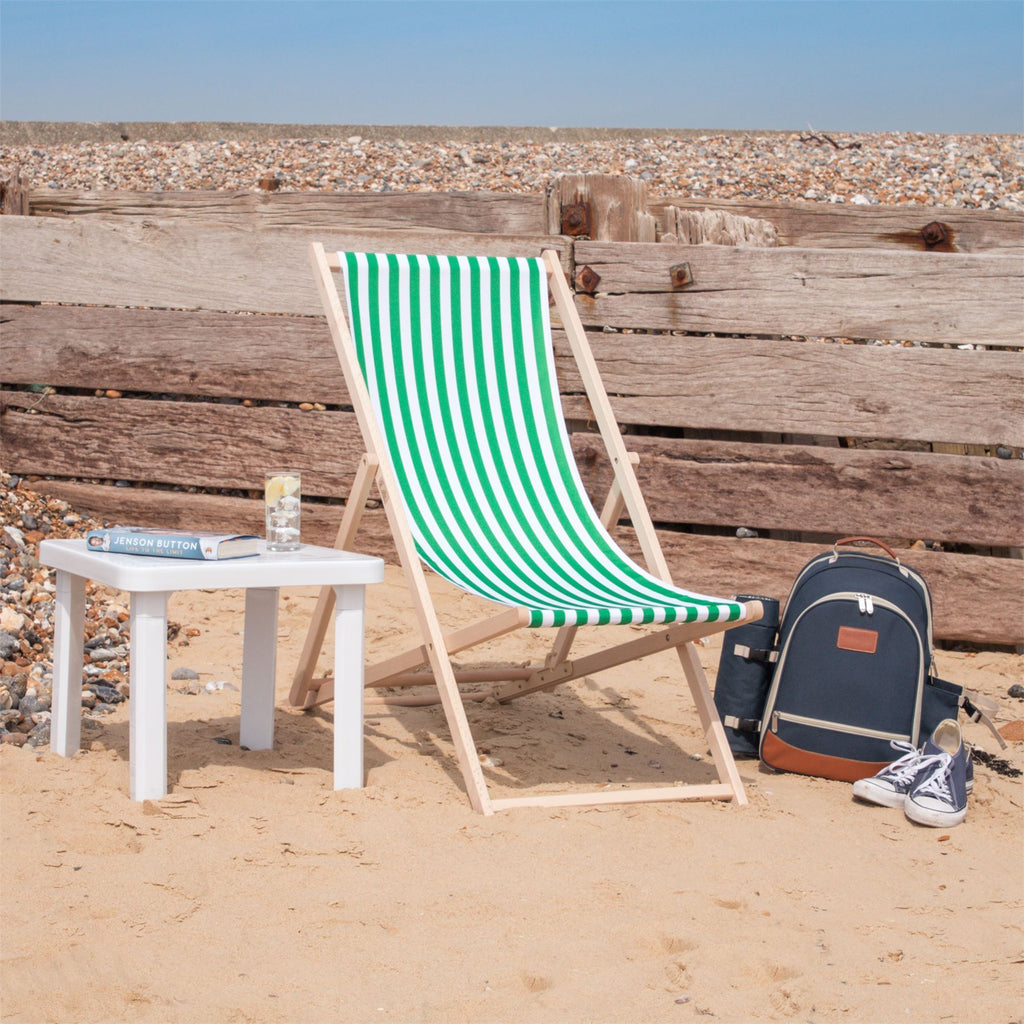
[289,243,762,814]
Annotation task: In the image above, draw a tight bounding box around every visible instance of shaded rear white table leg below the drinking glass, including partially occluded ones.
[239,587,278,751]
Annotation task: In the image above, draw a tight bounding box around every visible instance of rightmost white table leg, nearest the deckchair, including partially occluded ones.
[334,586,366,790]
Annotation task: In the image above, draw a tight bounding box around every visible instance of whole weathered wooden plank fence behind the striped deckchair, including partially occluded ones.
[6,176,1024,645]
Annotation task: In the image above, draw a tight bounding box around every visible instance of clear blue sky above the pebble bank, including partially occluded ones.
[0,0,1024,132]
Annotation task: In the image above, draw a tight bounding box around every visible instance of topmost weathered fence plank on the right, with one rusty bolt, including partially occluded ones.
[647,194,1024,256]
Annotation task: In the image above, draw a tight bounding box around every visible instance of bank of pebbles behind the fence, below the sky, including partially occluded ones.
[0,132,1024,211]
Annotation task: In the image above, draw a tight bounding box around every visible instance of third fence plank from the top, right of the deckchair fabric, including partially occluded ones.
[558,335,1024,446]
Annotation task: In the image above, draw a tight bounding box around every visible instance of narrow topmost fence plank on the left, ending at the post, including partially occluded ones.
[29,188,547,234]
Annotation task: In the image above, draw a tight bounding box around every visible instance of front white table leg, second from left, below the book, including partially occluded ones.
[128,591,167,800]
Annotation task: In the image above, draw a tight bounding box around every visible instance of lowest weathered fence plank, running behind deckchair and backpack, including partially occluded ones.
[25,480,1024,644]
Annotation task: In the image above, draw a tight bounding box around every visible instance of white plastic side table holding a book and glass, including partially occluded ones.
[39,540,384,800]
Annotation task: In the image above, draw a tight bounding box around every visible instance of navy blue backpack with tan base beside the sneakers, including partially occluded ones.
[715,537,1001,782]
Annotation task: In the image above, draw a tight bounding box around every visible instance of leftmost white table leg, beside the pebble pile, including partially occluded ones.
[50,569,85,758]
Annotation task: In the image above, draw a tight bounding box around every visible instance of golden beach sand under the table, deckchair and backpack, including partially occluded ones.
[0,568,1024,1024]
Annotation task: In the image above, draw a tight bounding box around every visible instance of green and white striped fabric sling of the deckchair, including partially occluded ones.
[339,253,743,626]
